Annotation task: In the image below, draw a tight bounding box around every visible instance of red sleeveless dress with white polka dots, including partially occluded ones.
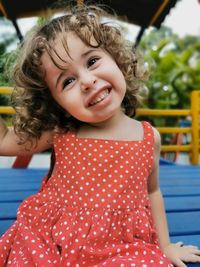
[0,122,173,267]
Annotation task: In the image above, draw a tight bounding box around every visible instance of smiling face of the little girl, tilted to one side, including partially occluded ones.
[42,32,126,123]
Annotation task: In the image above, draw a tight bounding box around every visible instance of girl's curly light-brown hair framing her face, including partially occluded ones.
[12,5,148,143]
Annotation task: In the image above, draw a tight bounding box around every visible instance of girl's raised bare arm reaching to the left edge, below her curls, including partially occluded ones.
[0,118,53,156]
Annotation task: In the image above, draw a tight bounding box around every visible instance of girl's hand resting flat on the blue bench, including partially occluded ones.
[163,242,200,267]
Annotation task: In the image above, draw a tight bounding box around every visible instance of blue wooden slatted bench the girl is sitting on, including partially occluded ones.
[0,163,200,267]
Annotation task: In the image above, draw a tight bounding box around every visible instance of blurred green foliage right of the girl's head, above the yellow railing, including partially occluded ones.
[139,27,200,109]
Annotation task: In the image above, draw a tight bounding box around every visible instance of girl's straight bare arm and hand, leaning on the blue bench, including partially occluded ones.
[148,129,200,267]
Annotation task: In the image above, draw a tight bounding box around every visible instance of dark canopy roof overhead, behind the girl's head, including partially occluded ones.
[0,0,180,44]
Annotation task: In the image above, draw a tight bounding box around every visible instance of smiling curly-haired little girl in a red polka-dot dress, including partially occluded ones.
[0,6,200,267]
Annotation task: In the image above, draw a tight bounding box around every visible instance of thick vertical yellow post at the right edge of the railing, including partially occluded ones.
[191,91,200,165]
